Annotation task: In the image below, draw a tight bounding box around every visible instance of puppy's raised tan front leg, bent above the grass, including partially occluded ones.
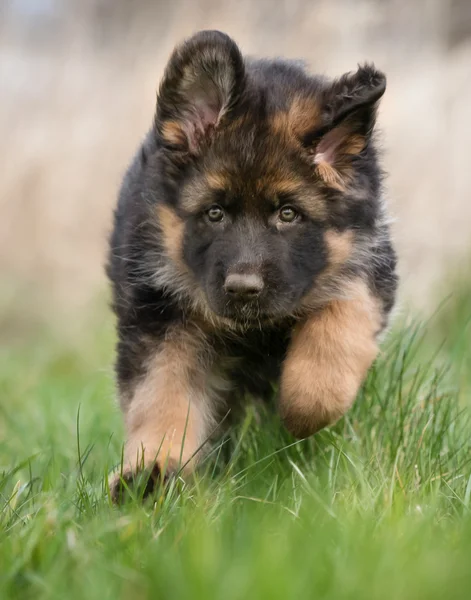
[280,280,382,438]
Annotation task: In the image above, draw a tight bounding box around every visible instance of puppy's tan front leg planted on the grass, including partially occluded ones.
[110,330,221,500]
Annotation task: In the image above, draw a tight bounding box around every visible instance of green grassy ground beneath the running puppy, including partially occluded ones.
[0,292,471,600]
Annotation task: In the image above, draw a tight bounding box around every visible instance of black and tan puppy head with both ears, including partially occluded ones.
[154,31,385,321]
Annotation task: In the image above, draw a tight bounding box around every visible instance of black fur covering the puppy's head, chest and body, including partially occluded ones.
[107,32,396,402]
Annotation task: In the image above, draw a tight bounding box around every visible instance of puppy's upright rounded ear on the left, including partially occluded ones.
[155,31,244,155]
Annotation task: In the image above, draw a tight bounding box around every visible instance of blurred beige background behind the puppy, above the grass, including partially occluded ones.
[0,0,471,340]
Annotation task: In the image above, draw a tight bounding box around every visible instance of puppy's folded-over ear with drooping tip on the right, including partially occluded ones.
[305,65,386,190]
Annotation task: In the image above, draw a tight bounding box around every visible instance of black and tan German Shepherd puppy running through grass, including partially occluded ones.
[108,31,397,497]
